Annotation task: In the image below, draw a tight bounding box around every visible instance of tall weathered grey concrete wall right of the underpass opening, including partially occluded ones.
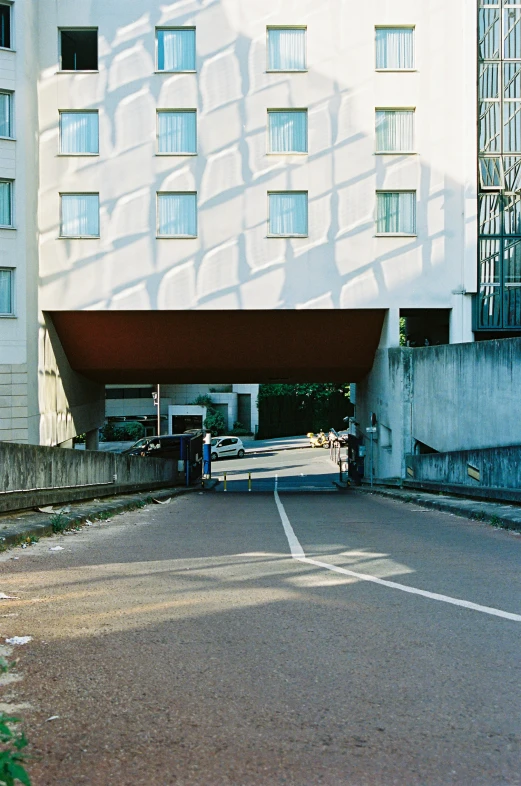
[356,338,521,482]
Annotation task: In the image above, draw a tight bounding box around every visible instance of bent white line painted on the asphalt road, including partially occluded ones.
[274,486,521,622]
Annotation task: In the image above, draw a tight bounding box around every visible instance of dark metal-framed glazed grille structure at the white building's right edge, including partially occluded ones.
[477,0,521,330]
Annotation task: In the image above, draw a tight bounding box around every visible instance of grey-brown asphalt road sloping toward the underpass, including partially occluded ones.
[0,451,521,786]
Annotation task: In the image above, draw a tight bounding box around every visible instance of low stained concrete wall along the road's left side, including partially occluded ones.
[0,442,177,512]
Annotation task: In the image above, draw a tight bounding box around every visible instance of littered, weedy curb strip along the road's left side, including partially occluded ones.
[0,486,201,551]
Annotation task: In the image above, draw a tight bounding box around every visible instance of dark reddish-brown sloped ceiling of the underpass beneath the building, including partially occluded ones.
[48,309,385,383]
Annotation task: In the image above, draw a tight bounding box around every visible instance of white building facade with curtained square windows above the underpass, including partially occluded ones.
[0,0,521,454]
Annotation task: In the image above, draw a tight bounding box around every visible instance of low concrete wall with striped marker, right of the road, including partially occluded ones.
[406,445,521,489]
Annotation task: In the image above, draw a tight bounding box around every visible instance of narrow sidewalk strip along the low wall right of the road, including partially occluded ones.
[357,486,521,532]
